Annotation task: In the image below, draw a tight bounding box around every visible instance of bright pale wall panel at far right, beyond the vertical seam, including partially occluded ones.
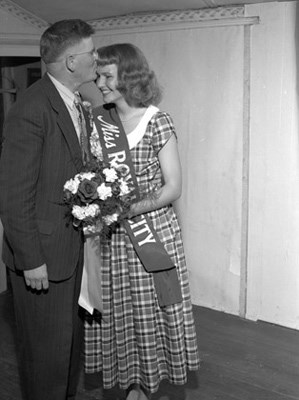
[246,2,299,329]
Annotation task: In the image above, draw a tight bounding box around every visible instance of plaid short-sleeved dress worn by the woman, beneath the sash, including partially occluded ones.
[85,111,199,392]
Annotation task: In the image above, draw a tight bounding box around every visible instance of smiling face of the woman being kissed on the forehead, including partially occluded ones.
[96,64,123,104]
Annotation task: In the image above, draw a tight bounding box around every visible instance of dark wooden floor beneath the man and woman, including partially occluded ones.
[0,291,299,400]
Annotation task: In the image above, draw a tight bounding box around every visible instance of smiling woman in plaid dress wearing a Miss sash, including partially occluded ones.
[86,43,199,400]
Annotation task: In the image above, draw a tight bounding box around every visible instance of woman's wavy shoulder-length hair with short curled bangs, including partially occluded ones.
[97,43,162,107]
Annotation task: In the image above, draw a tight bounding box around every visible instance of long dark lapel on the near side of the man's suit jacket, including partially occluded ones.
[42,74,83,172]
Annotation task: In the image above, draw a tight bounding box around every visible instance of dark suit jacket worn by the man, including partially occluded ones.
[0,74,83,281]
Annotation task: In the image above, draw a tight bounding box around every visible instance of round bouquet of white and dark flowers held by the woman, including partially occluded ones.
[63,159,131,235]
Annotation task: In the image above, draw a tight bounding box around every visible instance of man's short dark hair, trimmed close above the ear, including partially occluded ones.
[40,19,94,64]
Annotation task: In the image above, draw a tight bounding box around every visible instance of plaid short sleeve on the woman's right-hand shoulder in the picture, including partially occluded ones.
[151,112,177,153]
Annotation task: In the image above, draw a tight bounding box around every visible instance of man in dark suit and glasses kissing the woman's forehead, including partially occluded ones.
[0,20,97,400]
